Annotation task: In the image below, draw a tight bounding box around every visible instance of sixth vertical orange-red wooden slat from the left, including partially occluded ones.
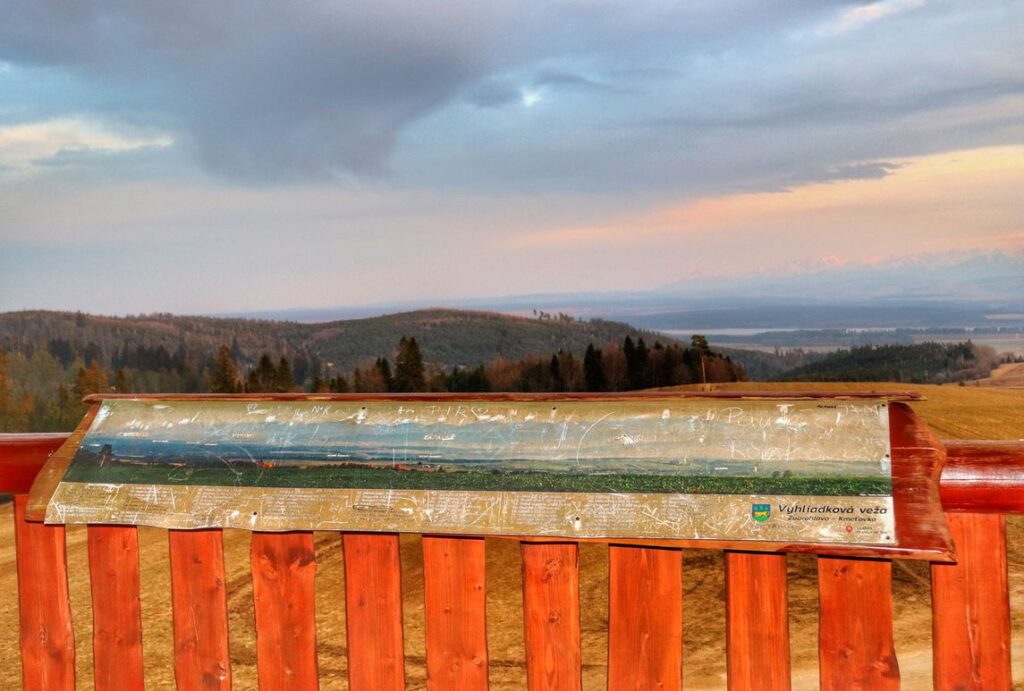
[423,535,487,691]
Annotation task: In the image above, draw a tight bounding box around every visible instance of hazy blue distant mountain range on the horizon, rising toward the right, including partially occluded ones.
[216,250,1024,329]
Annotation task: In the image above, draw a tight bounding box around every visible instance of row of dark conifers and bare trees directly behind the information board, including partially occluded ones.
[0,336,745,432]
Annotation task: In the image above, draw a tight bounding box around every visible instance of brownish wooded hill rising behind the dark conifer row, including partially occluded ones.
[0,309,676,371]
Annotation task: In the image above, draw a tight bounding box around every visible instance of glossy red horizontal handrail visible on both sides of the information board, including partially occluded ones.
[0,433,1024,514]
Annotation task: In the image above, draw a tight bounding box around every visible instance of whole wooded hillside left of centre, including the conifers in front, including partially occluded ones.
[0,310,745,431]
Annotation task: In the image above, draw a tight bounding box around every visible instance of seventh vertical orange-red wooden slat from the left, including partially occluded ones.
[521,543,583,691]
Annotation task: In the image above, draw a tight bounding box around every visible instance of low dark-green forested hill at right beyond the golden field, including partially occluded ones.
[777,341,999,384]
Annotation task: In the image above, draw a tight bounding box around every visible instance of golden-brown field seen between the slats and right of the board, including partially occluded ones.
[0,384,1024,691]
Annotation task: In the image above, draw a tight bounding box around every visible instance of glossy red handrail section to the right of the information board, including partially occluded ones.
[939,441,1024,514]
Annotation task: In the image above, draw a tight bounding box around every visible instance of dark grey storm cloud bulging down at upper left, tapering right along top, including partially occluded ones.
[0,0,864,181]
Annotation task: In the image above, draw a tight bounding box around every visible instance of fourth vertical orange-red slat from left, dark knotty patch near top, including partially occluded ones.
[251,532,319,691]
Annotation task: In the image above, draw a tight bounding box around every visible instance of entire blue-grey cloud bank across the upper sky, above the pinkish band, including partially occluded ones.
[0,0,1024,191]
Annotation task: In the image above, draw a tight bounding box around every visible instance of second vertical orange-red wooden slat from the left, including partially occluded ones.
[88,525,145,691]
